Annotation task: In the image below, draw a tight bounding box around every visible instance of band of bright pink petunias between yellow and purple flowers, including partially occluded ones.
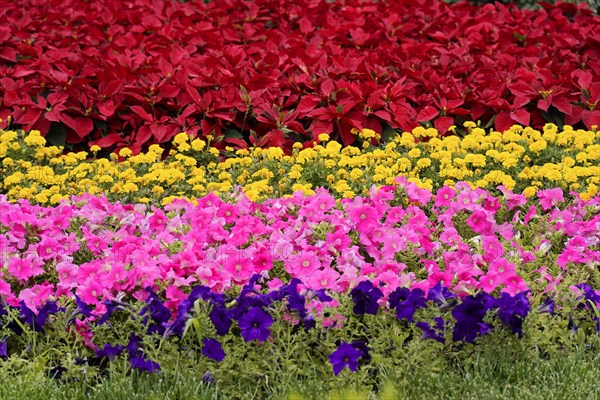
[0,178,600,312]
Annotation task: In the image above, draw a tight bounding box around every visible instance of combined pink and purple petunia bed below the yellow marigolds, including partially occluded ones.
[0,183,600,375]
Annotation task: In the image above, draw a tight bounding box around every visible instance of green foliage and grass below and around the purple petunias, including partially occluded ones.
[0,282,600,400]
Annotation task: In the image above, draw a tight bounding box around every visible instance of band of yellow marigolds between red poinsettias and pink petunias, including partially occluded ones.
[0,122,600,205]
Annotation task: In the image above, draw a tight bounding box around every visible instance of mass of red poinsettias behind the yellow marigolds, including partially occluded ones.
[0,0,600,151]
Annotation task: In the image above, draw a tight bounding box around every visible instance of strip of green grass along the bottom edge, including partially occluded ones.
[0,349,600,400]
